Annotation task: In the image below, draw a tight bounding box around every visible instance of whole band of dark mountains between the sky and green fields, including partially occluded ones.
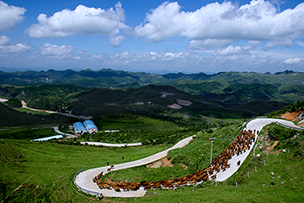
[0,69,304,125]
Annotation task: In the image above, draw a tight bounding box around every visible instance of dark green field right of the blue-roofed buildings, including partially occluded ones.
[77,115,198,145]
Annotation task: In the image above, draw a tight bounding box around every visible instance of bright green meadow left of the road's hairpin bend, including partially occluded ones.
[0,140,166,202]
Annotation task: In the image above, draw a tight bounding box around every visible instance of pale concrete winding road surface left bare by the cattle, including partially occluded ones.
[74,118,303,197]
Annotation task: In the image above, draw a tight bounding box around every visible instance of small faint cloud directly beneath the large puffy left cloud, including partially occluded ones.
[40,43,75,57]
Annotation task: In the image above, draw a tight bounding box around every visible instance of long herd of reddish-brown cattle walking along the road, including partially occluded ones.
[93,130,259,192]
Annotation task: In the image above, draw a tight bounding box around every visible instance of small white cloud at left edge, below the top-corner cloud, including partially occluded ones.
[0,35,31,53]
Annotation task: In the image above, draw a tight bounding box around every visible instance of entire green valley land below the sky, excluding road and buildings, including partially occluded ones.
[0,69,304,202]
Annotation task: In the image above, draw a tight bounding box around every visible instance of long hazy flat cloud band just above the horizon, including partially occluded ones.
[81,47,288,73]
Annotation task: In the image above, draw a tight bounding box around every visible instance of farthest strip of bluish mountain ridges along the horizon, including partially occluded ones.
[0,69,304,87]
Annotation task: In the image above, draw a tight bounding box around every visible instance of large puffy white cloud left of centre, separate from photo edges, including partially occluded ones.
[27,3,128,46]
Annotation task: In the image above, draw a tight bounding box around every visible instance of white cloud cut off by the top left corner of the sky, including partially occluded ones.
[0,1,26,31]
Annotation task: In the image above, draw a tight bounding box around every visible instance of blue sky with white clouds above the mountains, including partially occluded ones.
[0,0,304,73]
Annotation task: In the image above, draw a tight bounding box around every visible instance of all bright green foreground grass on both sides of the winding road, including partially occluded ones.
[0,117,304,202]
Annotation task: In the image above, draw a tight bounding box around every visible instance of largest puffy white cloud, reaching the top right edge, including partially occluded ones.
[134,0,304,46]
